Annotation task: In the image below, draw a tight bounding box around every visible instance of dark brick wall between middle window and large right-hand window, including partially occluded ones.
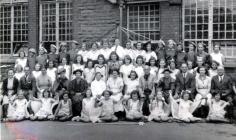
[160,2,182,41]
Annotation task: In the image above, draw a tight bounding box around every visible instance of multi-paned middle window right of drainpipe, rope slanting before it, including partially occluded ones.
[127,3,160,41]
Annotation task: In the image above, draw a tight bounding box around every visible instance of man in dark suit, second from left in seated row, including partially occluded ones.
[19,66,36,99]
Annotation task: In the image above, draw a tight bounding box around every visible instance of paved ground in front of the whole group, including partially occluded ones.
[1,121,236,140]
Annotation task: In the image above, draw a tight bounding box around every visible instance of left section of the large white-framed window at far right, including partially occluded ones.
[183,0,209,51]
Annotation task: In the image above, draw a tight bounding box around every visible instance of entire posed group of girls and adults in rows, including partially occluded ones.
[0,39,236,123]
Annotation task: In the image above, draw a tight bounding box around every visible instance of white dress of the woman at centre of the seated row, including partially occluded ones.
[107,77,124,112]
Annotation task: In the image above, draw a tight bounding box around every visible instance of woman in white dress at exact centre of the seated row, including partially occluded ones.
[107,69,124,118]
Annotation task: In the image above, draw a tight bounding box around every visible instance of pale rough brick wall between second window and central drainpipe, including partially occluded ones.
[73,0,119,42]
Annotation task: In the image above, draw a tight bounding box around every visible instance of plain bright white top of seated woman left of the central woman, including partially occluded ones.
[91,79,106,97]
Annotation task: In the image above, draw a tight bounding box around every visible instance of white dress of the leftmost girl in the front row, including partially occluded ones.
[8,99,28,118]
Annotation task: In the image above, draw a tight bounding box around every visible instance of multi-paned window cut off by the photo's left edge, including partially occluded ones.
[0,0,28,54]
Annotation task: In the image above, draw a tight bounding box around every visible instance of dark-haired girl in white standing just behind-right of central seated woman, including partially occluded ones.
[120,55,134,84]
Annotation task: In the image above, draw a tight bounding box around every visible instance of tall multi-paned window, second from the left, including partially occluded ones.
[40,0,72,45]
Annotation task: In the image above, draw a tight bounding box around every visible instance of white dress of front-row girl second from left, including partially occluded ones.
[35,98,55,117]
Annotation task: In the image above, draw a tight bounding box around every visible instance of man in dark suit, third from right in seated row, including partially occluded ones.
[174,63,195,99]
